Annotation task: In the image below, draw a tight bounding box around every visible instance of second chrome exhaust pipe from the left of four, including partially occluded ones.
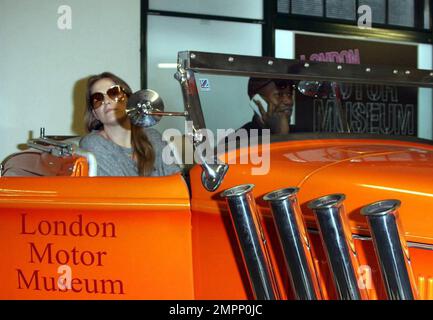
[263,188,321,300]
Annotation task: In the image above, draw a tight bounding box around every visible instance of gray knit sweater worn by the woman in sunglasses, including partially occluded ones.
[80,128,180,176]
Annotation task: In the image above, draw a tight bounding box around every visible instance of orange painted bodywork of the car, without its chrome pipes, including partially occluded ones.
[0,135,433,299]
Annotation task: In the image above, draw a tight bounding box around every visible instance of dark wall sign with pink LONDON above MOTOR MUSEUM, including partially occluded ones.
[295,34,418,136]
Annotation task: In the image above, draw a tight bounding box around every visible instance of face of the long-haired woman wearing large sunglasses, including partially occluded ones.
[90,78,127,126]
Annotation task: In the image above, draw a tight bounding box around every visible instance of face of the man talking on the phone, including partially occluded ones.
[261,82,293,118]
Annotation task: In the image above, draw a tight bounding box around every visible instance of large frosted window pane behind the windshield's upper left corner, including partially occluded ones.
[147,15,262,132]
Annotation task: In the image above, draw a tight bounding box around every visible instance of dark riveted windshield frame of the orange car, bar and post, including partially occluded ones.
[175,51,433,143]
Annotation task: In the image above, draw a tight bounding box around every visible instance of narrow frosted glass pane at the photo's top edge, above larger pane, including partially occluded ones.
[149,0,263,19]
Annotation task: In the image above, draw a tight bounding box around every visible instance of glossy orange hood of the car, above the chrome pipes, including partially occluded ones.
[213,139,433,244]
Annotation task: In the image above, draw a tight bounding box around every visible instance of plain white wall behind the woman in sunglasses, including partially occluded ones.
[0,0,140,161]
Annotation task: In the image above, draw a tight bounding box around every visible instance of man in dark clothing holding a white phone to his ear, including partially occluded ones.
[242,78,294,134]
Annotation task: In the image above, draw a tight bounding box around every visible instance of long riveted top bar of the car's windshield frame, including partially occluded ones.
[178,51,433,88]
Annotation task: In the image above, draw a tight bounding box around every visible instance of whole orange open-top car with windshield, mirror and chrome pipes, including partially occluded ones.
[0,52,433,299]
